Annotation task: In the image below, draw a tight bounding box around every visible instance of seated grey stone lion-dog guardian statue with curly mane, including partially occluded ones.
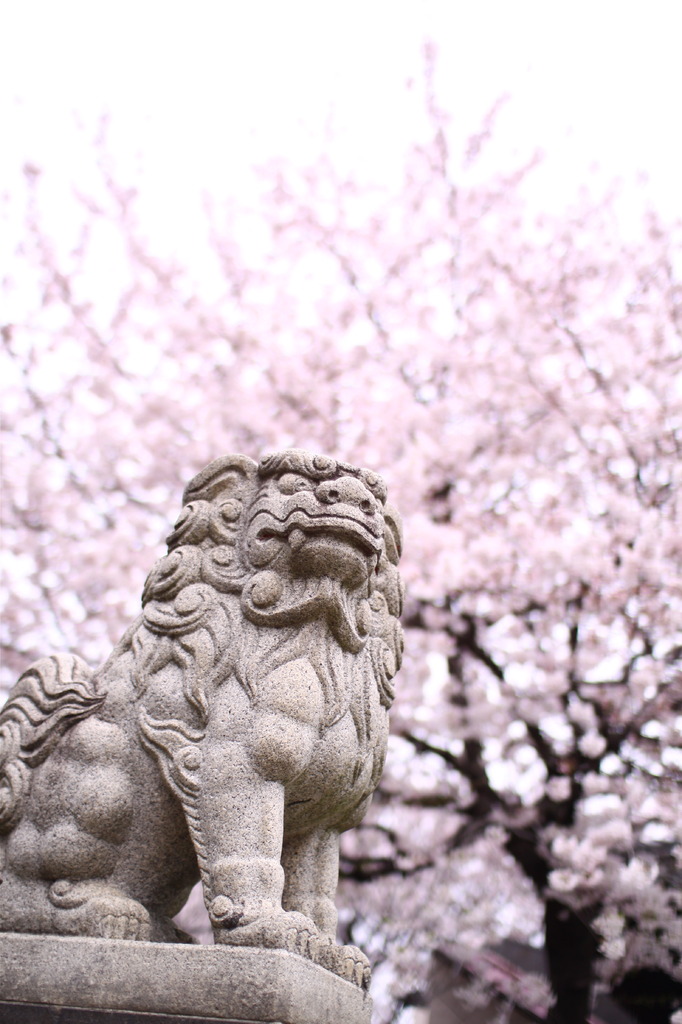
[0,450,402,985]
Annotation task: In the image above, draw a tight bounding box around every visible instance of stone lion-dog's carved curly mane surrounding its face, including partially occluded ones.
[117,451,402,733]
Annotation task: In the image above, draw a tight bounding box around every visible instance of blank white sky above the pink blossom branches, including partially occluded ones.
[0,0,682,239]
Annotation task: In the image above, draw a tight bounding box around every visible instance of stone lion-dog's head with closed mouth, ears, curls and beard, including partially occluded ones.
[143,449,401,650]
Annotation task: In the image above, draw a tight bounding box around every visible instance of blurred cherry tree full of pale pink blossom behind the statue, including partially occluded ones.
[2,74,682,1024]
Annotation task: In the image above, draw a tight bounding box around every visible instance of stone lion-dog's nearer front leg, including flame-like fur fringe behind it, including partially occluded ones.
[139,660,322,956]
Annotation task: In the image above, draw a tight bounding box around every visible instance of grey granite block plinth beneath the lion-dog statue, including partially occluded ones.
[0,933,372,1024]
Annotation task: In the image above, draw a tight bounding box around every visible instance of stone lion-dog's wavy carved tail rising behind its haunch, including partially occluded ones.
[0,654,104,835]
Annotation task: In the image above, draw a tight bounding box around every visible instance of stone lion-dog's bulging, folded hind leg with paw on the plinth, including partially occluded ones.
[0,718,150,939]
